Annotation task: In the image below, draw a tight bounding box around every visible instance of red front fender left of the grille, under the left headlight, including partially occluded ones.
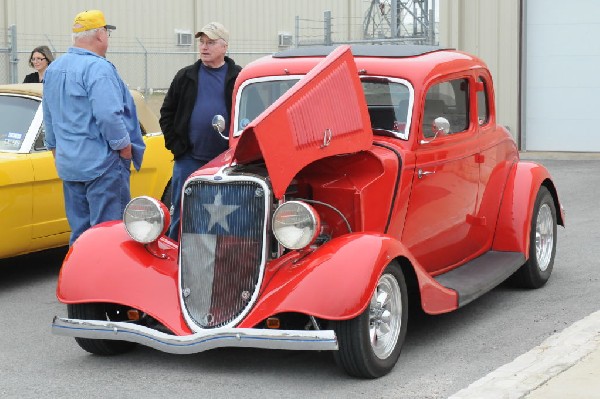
[56,221,191,335]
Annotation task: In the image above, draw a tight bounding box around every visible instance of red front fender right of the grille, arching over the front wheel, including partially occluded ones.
[240,233,457,327]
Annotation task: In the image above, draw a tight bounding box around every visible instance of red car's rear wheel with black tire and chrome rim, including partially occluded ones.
[513,186,556,288]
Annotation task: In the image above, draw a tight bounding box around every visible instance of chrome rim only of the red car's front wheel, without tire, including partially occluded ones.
[369,274,402,359]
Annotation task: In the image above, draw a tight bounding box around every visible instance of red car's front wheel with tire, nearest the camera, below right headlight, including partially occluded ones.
[333,262,408,378]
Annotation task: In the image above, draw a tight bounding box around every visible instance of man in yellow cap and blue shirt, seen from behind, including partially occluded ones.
[42,10,145,245]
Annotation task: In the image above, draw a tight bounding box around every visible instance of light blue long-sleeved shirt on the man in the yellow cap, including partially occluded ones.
[42,47,146,181]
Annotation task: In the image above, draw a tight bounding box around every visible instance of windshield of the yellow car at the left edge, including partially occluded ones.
[0,96,40,152]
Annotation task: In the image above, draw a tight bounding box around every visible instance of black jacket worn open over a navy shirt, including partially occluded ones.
[160,57,242,158]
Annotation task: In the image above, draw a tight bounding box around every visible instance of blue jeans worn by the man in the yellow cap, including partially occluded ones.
[63,157,131,246]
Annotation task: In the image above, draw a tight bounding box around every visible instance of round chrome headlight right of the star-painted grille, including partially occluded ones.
[273,201,321,249]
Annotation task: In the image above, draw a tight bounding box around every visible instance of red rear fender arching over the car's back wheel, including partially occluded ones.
[492,162,564,253]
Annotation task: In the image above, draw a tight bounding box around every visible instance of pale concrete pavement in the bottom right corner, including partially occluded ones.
[449,311,600,399]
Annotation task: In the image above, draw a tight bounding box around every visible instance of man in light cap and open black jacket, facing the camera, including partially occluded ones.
[160,22,242,240]
